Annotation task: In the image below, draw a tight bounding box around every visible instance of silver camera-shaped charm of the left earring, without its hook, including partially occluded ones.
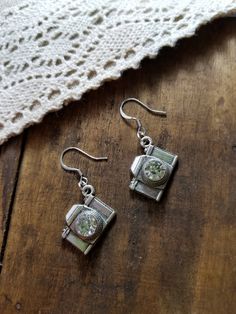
[62,195,116,255]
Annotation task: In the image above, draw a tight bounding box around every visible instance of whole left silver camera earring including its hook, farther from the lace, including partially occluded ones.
[60,147,116,255]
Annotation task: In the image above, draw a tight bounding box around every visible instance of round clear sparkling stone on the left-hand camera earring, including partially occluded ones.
[75,211,101,239]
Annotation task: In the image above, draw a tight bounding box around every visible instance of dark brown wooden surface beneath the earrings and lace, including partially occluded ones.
[0,19,236,314]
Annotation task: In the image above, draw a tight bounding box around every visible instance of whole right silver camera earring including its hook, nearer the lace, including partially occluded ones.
[120,98,178,201]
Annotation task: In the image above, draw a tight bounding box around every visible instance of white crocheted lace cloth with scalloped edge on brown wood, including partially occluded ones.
[0,0,236,144]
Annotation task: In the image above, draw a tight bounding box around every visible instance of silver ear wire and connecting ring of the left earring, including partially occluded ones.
[60,147,108,196]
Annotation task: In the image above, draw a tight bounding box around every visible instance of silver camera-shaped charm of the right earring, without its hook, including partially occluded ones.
[130,145,178,201]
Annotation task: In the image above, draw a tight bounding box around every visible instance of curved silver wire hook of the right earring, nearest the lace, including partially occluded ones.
[120,98,166,133]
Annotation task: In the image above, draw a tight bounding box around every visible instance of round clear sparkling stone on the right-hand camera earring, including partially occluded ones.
[143,160,167,182]
